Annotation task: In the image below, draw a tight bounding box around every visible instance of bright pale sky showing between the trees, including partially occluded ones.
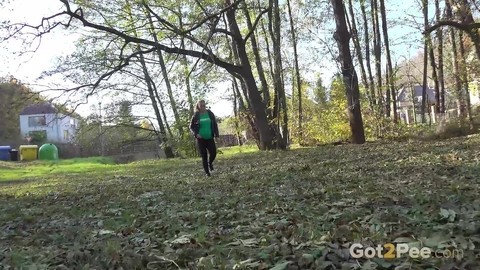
[0,0,428,120]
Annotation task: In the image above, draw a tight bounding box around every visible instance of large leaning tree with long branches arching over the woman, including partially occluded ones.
[5,0,286,150]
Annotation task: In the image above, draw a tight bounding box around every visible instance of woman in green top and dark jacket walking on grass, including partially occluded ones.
[190,100,218,176]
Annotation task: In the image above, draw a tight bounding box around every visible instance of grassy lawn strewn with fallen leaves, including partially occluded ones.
[0,136,480,270]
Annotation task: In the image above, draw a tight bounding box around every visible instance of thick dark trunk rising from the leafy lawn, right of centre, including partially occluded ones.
[331,0,365,144]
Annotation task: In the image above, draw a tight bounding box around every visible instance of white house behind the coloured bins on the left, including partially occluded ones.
[20,103,79,143]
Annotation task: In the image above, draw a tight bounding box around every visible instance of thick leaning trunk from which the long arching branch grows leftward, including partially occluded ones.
[225,0,274,150]
